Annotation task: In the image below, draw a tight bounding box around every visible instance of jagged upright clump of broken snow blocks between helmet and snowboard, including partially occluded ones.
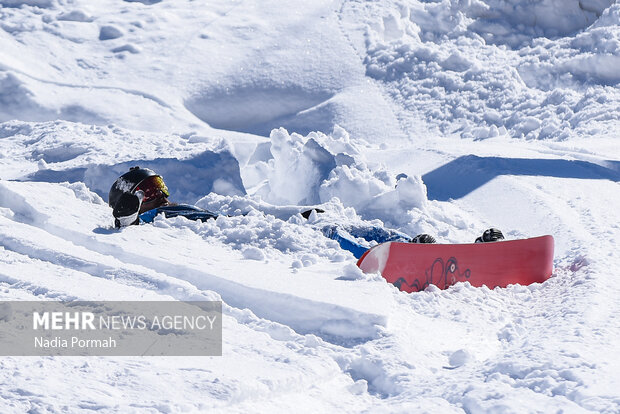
[249,127,426,223]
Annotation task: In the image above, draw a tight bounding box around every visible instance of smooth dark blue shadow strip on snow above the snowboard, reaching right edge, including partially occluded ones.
[422,155,620,201]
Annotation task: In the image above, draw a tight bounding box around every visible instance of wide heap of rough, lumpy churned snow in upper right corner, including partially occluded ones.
[348,0,620,140]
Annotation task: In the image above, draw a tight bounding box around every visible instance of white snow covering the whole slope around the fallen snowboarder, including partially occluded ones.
[0,0,620,413]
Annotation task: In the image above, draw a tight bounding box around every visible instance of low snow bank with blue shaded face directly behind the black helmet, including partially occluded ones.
[0,121,245,203]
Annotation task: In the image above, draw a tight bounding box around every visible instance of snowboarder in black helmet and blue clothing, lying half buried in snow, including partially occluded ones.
[108,167,504,259]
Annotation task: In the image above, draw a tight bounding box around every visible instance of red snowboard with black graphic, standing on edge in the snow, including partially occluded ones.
[357,236,553,292]
